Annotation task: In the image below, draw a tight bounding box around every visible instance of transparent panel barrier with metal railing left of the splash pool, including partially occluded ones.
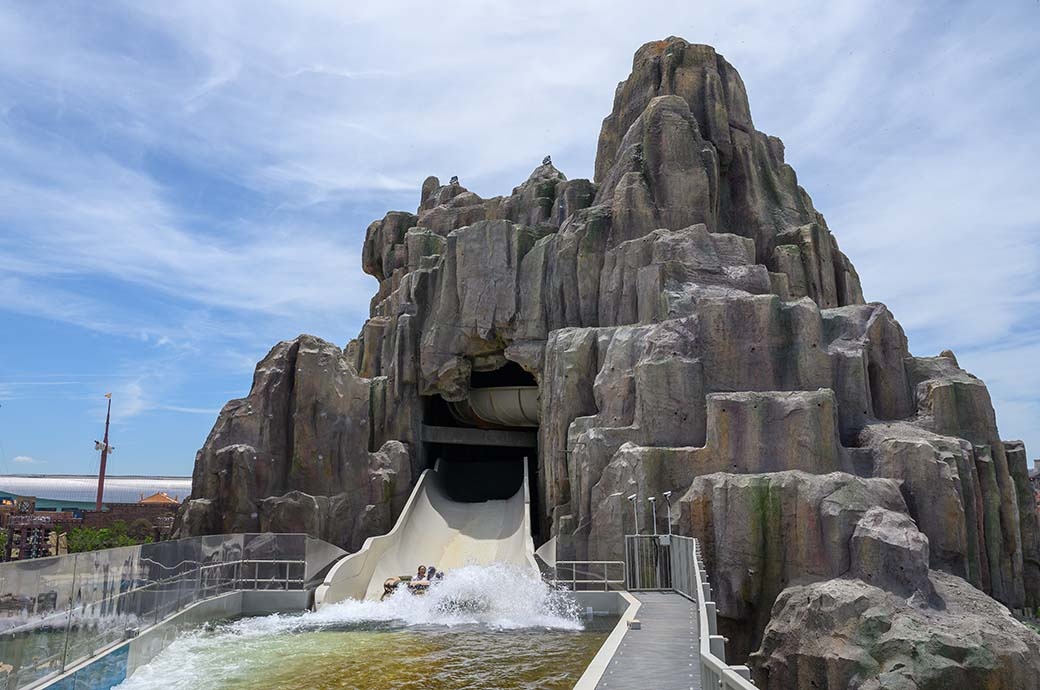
[0,534,344,690]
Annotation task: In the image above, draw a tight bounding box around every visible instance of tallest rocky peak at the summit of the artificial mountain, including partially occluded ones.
[595,36,844,272]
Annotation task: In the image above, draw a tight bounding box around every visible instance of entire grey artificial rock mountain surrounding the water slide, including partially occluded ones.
[180,37,1040,689]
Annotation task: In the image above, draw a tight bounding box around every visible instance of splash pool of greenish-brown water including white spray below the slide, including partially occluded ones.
[119,564,617,690]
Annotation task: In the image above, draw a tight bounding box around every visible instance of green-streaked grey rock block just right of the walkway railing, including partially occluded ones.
[679,471,906,658]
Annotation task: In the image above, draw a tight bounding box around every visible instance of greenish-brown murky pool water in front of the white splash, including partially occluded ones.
[121,618,616,690]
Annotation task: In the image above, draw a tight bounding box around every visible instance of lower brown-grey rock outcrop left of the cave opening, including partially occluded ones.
[174,335,412,548]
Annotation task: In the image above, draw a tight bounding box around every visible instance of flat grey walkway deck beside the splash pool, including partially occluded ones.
[596,592,701,690]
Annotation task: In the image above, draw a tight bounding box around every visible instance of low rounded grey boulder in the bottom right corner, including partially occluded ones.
[753,570,1040,690]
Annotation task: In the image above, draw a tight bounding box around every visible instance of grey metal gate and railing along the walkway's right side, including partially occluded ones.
[625,535,755,690]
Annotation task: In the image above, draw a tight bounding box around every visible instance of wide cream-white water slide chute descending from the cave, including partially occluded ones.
[314,461,539,609]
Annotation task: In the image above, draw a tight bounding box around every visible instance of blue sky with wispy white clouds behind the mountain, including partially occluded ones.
[0,0,1040,474]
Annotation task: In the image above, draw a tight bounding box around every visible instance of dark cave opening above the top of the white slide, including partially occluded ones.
[422,362,540,543]
